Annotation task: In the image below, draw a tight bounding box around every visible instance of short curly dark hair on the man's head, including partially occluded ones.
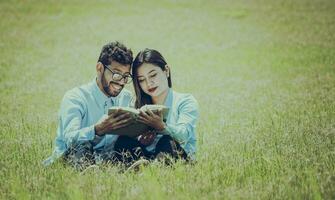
[98,41,133,65]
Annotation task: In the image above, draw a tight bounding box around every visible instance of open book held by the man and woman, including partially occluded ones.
[107,105,169,137]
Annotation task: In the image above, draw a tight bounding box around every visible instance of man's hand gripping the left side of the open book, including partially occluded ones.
[94,109,131,136]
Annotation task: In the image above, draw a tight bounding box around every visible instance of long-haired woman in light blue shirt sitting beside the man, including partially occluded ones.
[132,49,198,160]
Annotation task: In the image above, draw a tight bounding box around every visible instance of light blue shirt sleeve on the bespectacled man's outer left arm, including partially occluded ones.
[59,95,95,146]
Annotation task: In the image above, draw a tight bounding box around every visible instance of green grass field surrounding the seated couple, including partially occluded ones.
[0,0,335,199]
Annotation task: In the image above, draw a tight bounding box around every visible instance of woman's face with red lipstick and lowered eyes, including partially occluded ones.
[137,63,169,97]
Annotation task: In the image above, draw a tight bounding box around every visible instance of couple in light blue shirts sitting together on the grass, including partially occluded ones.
[44,42,198,170]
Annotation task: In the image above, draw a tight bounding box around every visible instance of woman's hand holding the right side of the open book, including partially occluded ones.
[138,110,165,132]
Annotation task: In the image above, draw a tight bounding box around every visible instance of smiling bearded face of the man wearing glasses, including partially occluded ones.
[101,61,130,97]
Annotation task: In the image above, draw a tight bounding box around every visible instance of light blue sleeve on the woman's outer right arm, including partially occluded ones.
[164,95,199,144]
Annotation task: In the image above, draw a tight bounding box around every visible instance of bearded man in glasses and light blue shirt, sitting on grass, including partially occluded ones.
[44,42,140,169]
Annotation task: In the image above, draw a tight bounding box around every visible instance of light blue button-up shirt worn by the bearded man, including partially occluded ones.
[43,79,132,165]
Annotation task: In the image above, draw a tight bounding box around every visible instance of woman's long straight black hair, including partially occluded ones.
[132,49,172,108]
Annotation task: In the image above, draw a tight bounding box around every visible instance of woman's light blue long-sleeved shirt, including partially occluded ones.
[147,88,199,160]
